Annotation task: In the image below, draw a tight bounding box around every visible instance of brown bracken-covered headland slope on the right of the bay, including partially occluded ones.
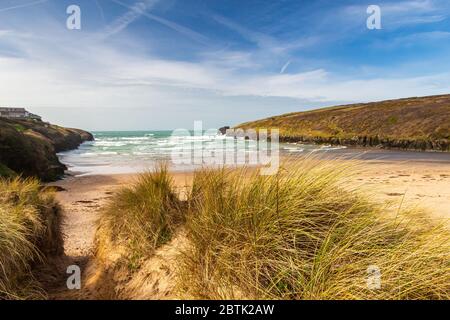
[236,95,450,151]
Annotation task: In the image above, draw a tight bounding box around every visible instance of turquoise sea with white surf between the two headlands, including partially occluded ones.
[58,130,343,176]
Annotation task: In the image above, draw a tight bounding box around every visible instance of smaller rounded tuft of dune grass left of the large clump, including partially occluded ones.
[97,165,184,270]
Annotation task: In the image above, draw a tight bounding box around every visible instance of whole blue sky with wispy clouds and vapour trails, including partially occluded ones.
[0,0,450,130]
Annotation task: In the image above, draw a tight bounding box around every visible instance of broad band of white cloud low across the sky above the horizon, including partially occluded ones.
[0,26,450,110]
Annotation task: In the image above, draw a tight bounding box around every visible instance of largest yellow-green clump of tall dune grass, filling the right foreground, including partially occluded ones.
[180,159,450,299]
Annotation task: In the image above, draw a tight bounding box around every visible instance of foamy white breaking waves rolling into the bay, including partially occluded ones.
[58,133,345,176]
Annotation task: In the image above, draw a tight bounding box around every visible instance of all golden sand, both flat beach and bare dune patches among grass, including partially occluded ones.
[39,150,450,299]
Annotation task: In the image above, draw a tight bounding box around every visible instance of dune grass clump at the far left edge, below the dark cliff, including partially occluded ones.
[0,178,62,299]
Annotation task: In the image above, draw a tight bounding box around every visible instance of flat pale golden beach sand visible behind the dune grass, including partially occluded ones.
[51,155,450,258]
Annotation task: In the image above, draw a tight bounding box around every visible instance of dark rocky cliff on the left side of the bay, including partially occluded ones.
[0,118,94,181]
